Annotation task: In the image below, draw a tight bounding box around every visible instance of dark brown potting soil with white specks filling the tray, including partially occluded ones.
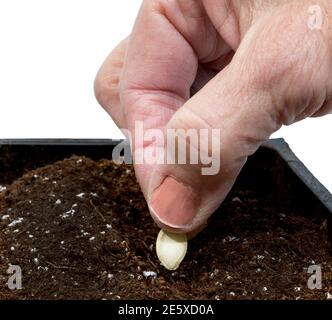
[0,145,332,300]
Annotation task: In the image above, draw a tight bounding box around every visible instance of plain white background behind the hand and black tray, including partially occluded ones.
[0,0,332,192]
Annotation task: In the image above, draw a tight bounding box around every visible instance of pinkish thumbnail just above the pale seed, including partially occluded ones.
[150,177,199,228]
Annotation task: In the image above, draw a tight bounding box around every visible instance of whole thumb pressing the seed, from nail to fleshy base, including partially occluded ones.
[148,8,331,233]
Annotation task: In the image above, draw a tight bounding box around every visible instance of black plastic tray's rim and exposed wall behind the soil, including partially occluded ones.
[0,139,332,214]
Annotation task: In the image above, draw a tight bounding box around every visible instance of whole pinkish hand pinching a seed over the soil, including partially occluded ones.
[95,0,332,233]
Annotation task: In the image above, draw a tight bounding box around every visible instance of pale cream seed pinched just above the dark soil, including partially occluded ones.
[156,230,188,270]
